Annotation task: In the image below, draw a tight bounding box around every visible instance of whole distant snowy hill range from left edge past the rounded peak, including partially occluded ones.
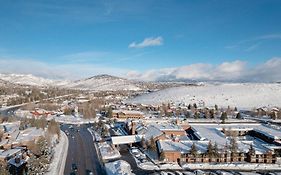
[0,74,201,91]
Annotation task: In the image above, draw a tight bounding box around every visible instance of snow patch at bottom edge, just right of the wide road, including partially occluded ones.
[105,160,134,175]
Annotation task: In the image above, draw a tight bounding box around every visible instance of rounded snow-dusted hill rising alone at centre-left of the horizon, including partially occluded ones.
[64,75,142,91]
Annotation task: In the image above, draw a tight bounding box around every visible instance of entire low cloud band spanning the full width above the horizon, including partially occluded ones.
[0,57,281,82]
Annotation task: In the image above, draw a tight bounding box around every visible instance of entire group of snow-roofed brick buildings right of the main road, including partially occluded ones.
[106,106,281,167]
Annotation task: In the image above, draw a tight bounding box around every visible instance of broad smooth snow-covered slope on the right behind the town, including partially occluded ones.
[127,83,281,109]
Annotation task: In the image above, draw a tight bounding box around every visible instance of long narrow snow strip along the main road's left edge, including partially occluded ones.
[46,131,68,175]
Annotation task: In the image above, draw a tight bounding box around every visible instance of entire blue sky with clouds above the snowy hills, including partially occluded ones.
[0,0,281,81]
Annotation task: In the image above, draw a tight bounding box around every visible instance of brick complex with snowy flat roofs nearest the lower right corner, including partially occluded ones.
[157,123,281,164]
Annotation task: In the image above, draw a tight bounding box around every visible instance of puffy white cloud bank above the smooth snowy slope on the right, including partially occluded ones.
[128,58,281,82]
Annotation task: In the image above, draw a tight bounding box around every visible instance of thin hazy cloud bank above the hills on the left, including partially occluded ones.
[0,57,130,80]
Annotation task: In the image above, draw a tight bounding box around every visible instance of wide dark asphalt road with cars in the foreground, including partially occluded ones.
[61,125,104,175]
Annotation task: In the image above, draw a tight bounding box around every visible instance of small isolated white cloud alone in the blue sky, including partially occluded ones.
[128,36,163,48]
